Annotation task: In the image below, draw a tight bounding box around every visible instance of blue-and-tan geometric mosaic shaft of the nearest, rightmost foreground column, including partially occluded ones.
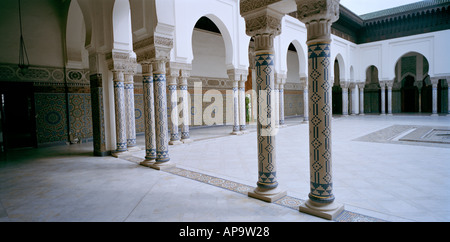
[308,43,334,202]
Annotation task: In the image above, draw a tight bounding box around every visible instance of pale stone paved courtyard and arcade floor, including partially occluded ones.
[0,115,450,222]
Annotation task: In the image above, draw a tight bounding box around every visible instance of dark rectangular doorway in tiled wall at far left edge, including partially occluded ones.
[0,82,36,150]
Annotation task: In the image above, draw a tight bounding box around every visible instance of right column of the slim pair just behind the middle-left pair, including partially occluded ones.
[178,68,192,143]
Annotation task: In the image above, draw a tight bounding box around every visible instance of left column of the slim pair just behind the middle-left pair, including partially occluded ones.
[167,63,182,145]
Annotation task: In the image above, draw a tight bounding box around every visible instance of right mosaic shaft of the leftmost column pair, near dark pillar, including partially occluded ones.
[124,73,136,147]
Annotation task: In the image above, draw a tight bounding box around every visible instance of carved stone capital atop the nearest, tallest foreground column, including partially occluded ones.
[295,0,339,44]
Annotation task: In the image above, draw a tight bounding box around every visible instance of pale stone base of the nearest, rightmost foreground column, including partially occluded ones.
[299,199,344,220]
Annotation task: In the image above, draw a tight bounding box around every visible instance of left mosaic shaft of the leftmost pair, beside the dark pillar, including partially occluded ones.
[113,71,127,152]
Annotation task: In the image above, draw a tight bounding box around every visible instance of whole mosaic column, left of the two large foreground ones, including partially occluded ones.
[240,4,287,202]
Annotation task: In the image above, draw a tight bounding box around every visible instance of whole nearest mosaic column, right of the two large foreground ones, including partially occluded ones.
[296,0,344,219]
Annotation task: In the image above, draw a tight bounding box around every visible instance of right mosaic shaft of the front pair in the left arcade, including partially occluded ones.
[153,60,170,163]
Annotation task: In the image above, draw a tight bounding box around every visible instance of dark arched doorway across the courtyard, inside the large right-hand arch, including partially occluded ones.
[401,76,419,113]
